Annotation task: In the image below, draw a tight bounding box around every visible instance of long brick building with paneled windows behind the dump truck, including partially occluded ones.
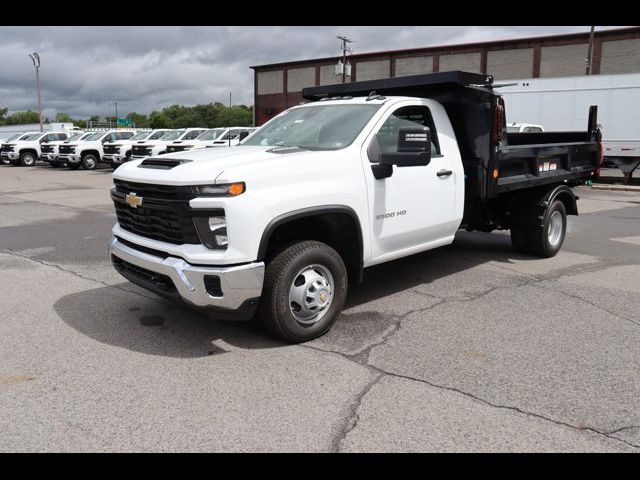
[251,27,640,125]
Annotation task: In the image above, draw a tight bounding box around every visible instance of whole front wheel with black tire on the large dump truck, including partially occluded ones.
[260,241,347,343]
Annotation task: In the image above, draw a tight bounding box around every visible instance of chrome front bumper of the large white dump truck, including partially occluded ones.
[109,237,264,320]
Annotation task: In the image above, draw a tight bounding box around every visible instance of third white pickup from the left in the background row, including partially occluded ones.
[58,129,136,170]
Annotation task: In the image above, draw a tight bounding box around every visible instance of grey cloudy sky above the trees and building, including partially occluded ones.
[0,26,614,118]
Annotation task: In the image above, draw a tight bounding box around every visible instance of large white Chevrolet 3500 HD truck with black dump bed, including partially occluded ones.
[110,72,601,342]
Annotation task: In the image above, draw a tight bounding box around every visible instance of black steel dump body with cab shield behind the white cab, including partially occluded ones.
[302,71,600,228]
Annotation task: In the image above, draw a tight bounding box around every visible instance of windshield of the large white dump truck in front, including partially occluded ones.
[242,104,380,150]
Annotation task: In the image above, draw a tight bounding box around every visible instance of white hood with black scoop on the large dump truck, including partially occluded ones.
[113,146,326,185]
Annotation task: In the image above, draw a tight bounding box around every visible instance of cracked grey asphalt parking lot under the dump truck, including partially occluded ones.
[0,166,640,452]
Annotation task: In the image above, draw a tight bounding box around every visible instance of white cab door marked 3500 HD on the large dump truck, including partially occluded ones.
[362,101,457,264]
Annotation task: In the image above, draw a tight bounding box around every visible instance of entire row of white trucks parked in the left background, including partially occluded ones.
[0,127,254,170]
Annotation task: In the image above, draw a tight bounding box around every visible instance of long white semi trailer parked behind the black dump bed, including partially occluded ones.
[497,73,640,183]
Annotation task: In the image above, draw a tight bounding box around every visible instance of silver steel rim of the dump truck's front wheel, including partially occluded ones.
[289,264,335,325]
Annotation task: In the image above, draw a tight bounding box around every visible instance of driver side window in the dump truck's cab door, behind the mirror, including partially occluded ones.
[370,105,441,163]
